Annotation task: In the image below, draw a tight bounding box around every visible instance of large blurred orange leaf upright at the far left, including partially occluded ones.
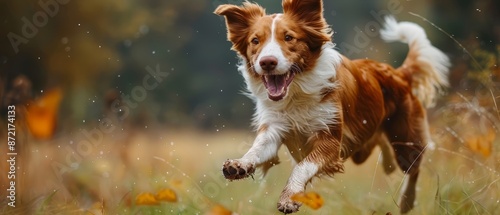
[26,88,62,139]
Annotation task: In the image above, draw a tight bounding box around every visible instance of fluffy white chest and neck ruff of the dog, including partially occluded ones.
[238,43,342,133]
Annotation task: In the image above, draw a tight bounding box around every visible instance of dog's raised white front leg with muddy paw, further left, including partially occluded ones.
[222,125,281,180]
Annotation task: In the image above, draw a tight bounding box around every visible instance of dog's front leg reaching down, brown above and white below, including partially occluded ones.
[278,131,344,214]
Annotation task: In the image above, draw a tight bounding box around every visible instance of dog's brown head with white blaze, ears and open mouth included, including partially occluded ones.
[215,0,331,101]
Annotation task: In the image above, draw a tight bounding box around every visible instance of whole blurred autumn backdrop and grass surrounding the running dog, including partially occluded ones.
[0,0,500,215]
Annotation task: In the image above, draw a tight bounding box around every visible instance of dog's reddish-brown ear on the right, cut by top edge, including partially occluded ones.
[283,0,332,49]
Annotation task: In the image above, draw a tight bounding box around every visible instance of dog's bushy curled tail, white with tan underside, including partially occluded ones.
[380,16,450,107]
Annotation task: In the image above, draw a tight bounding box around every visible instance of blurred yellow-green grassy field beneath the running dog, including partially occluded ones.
[0,123,500,215]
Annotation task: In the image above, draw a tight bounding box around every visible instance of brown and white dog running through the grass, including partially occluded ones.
[215,0,449,214]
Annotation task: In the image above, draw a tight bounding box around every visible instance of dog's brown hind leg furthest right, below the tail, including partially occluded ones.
[385,96,429,213]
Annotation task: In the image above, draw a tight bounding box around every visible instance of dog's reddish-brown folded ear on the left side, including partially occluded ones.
[214,2,266,54]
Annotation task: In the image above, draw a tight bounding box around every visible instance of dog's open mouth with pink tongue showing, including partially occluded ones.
[262,71,295,101]
